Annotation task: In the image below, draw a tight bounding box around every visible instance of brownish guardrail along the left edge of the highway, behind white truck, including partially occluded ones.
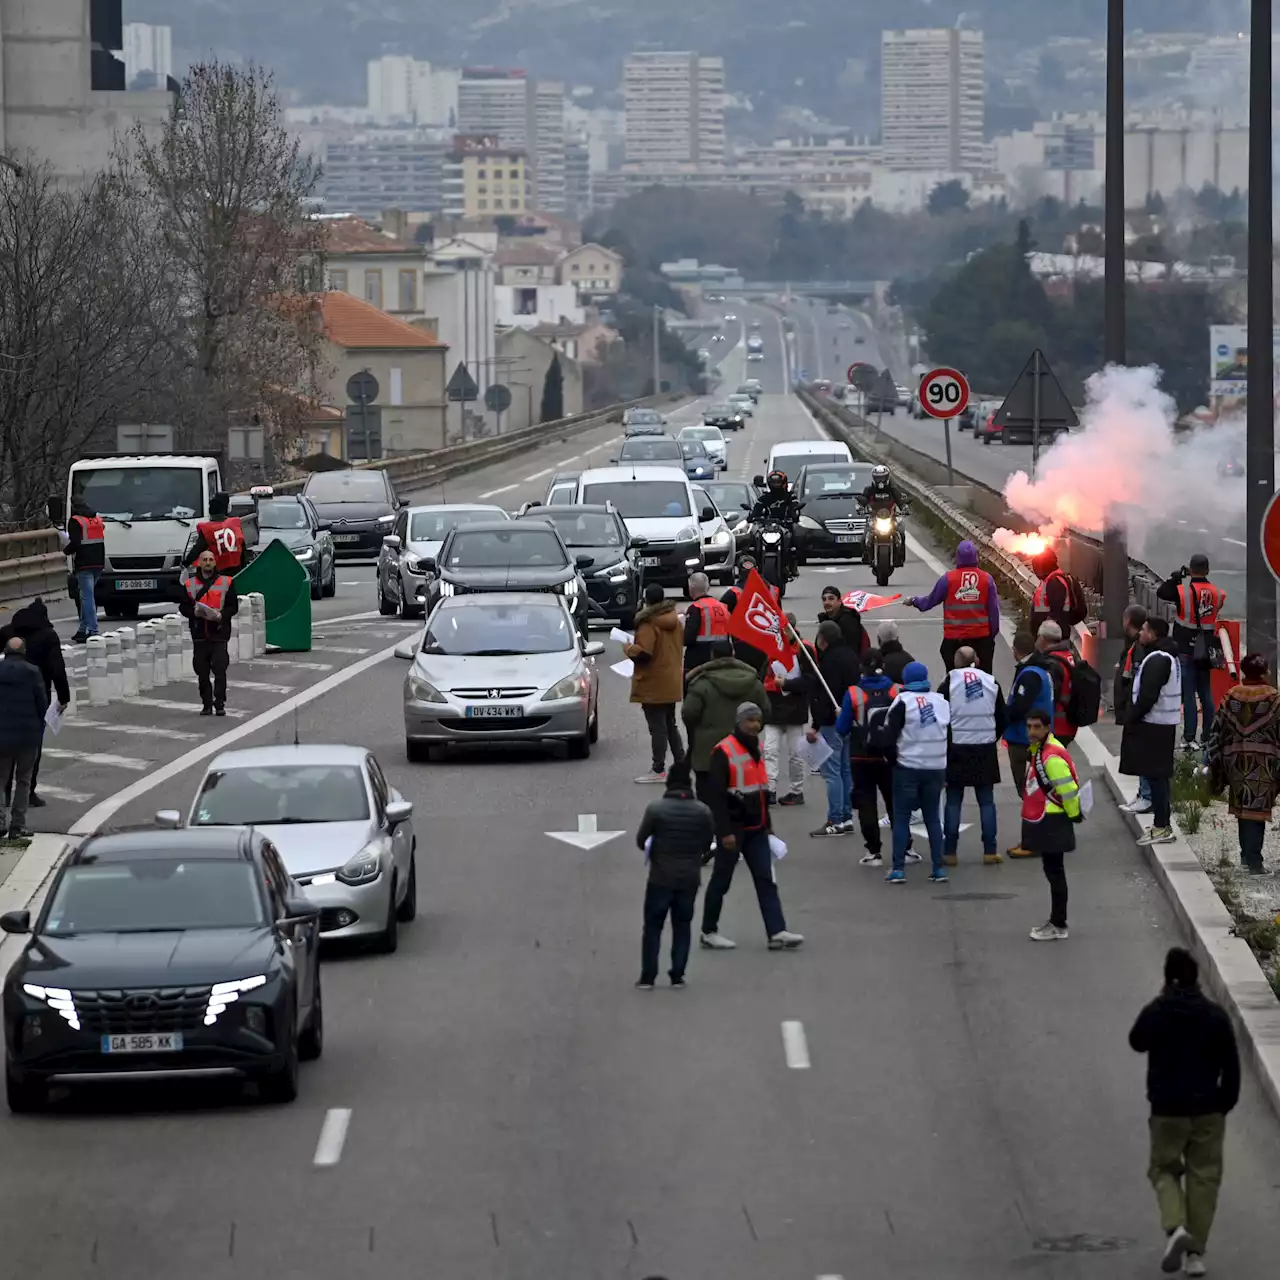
[0,393,686,602]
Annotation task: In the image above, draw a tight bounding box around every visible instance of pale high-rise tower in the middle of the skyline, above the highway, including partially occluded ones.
[622,51,724,170]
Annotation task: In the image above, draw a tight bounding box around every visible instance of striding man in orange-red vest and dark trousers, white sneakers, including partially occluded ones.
[700,703,804,951]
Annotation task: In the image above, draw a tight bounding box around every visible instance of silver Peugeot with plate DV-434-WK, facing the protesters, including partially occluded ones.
[396,591,604,762]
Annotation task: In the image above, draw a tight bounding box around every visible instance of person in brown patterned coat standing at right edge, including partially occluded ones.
[1208,653,1280,876]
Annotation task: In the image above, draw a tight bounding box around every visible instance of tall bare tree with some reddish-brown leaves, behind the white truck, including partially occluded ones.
[127,63,324,458]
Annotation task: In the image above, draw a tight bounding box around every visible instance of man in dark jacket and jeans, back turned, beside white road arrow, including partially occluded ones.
[636,760,716,991]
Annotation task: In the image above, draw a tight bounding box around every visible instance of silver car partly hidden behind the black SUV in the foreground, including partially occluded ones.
[170,746,417,951]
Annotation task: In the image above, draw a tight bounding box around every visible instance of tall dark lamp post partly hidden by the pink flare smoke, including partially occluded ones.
[1102,0,1129,671]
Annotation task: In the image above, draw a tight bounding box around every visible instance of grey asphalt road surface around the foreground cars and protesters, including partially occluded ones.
[0,368,1280,1280]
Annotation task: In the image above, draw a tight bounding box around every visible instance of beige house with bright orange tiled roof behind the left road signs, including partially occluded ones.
[317,291,448,458]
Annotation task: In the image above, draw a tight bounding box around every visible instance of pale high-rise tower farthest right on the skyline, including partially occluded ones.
[881,27,986,173]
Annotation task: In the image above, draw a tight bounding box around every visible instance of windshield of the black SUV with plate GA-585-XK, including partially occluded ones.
[44,856,268,938]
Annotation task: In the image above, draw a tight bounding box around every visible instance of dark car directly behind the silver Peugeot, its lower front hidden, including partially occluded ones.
[422,520,595,639]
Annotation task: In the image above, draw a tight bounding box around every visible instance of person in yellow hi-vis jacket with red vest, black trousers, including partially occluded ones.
[1019,708,1084,942]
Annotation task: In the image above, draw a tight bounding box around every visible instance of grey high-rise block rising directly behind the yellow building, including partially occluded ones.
[458,68,564,214]
